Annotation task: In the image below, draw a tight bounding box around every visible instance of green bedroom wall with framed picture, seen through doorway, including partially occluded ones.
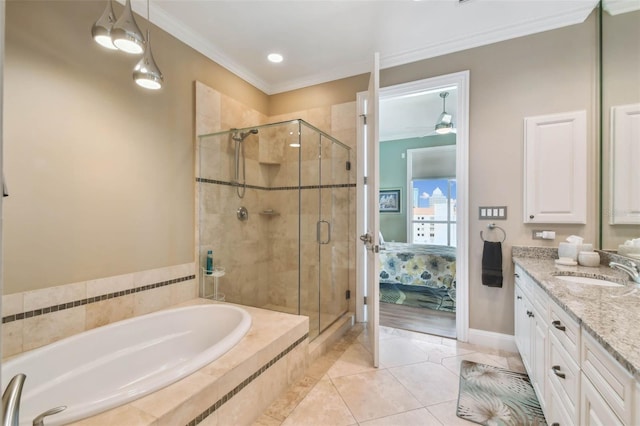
[380,134,456,243]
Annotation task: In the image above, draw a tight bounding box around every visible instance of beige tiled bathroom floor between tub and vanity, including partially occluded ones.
[254,324,524,426]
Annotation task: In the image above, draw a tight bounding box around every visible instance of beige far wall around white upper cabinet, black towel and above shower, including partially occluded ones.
[271,14,598,334]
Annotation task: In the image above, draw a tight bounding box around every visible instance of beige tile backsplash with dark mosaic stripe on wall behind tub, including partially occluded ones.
[2,263,197,358]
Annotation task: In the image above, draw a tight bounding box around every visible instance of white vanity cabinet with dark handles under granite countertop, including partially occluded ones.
[514,265,640,426]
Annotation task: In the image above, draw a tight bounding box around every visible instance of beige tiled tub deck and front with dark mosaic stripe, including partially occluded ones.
[73,299,309,426]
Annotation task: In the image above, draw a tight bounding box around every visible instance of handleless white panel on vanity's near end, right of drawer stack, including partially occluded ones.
[580,331,636,425]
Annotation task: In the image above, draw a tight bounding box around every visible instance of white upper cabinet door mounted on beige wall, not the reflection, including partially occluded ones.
[524,111,587,223]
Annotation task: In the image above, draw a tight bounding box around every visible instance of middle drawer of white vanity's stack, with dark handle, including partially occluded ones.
[547,335,580,423]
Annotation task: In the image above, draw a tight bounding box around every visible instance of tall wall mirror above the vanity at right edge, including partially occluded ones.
[600,0,640,258]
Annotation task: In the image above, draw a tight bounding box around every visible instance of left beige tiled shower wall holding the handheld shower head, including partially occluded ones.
[195,82,271,312]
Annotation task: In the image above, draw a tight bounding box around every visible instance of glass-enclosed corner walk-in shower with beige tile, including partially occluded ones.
[197,120,355,338]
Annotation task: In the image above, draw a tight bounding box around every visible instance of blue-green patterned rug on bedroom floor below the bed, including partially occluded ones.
[380,283,456,312]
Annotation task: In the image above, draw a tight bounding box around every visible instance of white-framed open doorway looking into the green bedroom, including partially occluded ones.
[359,71,469,341]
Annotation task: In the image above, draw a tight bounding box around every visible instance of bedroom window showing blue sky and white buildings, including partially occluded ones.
[410,178,456,246]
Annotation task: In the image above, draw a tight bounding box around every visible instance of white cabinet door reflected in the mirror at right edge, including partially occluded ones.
[611,104,640,225]
